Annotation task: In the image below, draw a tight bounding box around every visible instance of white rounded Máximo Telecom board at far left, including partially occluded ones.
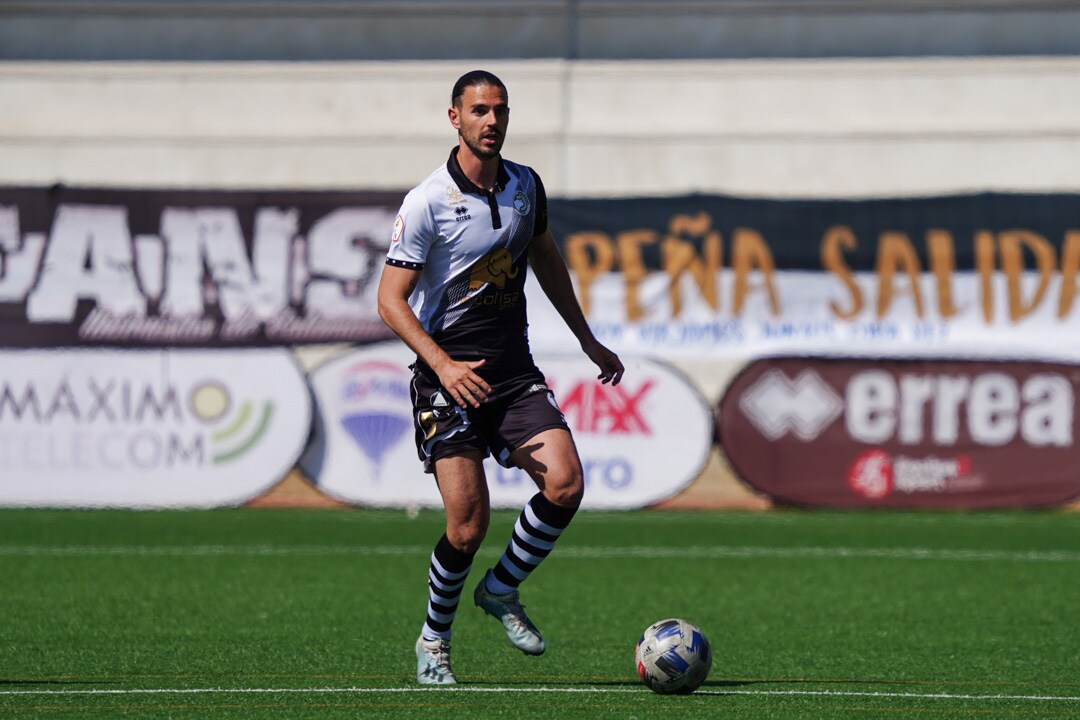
[0,349,311,507]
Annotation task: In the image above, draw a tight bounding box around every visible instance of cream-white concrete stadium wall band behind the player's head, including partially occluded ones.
[0,57,1080,198]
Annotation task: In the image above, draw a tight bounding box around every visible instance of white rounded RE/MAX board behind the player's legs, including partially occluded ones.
[300,342,713,508]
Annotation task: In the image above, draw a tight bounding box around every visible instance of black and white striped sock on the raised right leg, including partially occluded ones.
[485,492,577,595]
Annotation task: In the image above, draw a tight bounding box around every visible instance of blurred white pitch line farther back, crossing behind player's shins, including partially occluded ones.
[0,545,1080,562]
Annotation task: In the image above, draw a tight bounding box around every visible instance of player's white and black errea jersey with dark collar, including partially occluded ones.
[387,148,548,379]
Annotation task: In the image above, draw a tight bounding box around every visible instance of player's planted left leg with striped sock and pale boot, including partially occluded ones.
[416,450,491,684]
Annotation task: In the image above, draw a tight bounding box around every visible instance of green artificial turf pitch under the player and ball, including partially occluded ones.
[0,510,1080,719]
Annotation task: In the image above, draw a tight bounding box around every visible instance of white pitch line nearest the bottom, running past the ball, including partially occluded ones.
[0,685,1080,703]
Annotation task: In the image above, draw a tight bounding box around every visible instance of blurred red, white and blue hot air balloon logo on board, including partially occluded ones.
[341,361,413,483]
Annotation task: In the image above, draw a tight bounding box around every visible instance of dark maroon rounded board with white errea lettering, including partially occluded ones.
[717,357,1080,507]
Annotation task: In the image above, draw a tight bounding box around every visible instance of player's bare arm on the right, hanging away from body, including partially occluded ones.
[529,230,624,385]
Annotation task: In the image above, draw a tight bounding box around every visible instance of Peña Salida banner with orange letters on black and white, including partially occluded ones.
[531,193,1080,362]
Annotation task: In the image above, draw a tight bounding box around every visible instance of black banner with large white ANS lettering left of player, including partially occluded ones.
[0,187,402,348]
